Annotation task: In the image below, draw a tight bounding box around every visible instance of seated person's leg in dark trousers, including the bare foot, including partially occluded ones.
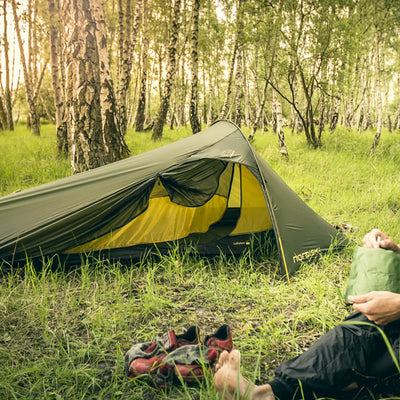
[214,313,399,400]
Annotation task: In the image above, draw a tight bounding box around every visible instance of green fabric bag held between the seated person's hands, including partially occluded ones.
[345,246,400,303]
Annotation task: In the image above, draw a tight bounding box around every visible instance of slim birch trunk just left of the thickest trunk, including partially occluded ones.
[47,0,68,154]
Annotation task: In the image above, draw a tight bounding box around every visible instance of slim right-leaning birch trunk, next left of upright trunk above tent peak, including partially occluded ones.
[151,0,181,140]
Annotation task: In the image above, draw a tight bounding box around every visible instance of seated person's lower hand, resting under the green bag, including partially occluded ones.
[349,291,400,325]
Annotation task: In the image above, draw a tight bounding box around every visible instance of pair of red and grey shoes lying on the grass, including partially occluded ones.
[125,325,233,389]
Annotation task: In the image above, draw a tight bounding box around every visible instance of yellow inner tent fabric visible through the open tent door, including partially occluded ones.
[66,163,272,253]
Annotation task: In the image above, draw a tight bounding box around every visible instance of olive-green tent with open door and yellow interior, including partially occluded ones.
[0,121,347,278]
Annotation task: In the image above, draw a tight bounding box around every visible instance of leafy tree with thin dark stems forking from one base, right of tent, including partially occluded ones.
[270,0,343,148]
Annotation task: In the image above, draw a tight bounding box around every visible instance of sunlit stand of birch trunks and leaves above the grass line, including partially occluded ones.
[0,0,400,167]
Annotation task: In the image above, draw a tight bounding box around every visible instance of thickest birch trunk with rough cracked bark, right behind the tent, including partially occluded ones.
[63,0,108,174]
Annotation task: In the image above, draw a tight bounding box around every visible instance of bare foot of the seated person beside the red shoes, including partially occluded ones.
[214,350,275,400]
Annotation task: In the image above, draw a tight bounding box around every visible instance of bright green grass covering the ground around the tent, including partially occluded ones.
[0,125,400,400]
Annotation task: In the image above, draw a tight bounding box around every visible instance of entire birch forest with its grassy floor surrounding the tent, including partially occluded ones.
[0,0,400,400]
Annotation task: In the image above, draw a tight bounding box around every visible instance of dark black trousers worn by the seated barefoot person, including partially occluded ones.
[270,313,400,400]
